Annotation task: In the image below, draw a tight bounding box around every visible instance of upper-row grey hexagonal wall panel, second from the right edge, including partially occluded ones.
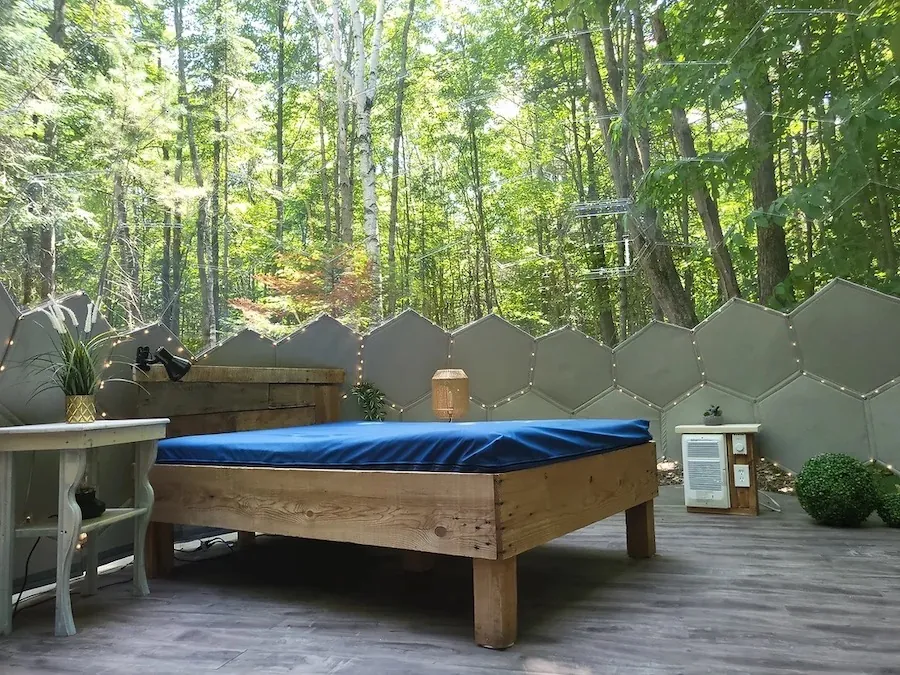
[694,300,800,398]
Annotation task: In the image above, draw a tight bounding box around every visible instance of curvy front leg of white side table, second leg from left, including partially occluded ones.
[56,450,87,636]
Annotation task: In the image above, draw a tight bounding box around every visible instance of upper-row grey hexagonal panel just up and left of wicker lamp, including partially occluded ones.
[363,310,450,406]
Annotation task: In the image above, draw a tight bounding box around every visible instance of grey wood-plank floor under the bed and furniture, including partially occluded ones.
[0,488,900,675]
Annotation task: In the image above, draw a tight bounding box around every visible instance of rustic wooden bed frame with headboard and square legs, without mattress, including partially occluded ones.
[139,366,658,649]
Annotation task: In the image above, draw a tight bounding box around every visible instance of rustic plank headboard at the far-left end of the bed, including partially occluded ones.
[134,365,344,437]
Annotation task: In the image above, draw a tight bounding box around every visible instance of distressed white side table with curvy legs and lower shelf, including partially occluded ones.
[0,419,169,635]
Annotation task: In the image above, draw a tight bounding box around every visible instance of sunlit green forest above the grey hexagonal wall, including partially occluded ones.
[0,0,900,350]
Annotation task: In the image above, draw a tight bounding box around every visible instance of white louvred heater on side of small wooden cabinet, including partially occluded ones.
[681,434,731,509]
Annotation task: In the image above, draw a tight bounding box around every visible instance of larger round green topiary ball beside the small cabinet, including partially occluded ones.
[795,452,878,527]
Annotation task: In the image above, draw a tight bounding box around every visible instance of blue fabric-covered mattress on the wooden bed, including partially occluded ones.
[156,419,651,473]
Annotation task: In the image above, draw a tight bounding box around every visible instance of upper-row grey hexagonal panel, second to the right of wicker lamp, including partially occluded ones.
[533,328,612,410]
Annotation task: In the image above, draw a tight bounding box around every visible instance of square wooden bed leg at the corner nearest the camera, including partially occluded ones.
[472,556,519,649]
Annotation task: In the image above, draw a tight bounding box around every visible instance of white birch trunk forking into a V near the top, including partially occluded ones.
[350,0,384,321]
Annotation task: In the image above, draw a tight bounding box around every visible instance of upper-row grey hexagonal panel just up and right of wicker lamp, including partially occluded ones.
[450,314,534,403]
